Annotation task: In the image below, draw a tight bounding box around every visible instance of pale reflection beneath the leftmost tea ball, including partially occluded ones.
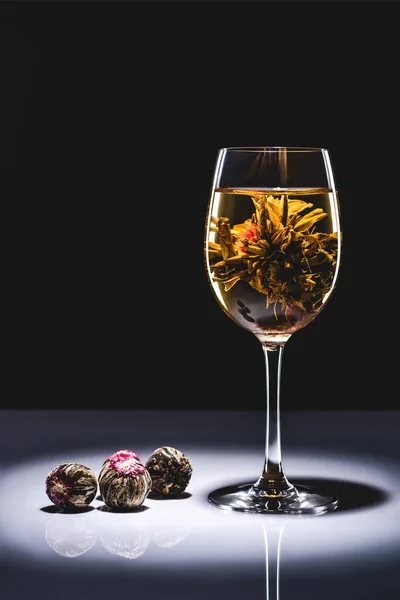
[45,513,97,558]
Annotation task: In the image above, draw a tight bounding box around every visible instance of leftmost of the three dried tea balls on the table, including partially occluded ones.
[46,463,97,510]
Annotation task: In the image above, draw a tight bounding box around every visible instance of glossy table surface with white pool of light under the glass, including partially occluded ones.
[0,410,400,600]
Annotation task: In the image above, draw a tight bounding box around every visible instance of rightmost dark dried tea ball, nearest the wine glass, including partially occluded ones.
[146,446,192,496]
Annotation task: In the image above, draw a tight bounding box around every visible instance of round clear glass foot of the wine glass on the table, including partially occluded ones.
[208,483,339,515]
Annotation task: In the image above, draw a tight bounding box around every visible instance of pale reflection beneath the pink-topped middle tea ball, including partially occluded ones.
[99,519,151,559]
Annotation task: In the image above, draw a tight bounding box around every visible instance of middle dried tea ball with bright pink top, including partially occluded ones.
[99,450,151,510]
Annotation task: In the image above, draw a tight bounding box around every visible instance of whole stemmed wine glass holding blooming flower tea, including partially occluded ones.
[204,146,342,514]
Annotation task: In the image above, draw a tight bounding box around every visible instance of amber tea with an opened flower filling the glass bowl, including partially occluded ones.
[205,188,341,339]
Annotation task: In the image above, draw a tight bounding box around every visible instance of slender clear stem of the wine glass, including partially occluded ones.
[254,342,296,498]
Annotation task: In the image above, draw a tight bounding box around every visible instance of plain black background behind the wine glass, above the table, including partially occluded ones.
[0,1,399,410]
